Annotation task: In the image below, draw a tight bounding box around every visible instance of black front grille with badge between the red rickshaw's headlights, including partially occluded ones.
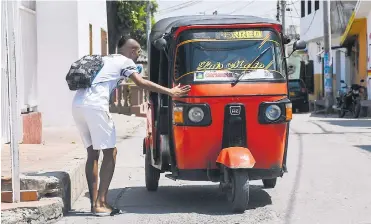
[222,104,247,148]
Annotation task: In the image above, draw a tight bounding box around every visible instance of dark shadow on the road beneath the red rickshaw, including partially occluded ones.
[108,185,272,215]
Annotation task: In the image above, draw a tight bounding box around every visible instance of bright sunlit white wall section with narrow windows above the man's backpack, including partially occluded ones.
[77,0,108,57]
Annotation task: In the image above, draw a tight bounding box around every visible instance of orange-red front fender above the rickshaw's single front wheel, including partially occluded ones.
[216,147,255,169]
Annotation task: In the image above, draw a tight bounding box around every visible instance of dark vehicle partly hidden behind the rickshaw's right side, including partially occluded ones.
[289,79,309,112]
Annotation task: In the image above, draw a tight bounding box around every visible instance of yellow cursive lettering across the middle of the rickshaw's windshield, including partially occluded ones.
[197,60,266,70]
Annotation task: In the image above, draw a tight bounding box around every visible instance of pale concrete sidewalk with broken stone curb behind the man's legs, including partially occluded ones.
[1,114,145,223]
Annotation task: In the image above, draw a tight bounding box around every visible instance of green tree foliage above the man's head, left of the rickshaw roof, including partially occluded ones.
[117,0,158,47]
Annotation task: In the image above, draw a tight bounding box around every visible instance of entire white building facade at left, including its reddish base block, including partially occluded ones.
[1,0,108,143]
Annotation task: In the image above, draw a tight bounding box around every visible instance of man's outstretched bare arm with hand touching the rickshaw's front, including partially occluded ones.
[130,72,191,97]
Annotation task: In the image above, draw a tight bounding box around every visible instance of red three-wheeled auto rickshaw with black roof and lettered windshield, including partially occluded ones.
[143,15,306,212]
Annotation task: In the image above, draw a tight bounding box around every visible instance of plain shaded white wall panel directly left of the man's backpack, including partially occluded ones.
[36,1,78,126]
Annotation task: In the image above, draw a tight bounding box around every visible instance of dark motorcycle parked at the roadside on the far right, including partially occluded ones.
[333,79,366,118]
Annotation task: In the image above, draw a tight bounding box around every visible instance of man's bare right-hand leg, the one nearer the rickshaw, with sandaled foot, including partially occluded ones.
[95,148,117,213]
